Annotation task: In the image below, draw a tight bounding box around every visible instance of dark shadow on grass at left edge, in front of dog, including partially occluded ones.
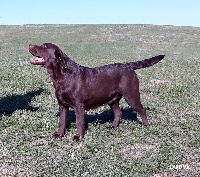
[0,88,44,118]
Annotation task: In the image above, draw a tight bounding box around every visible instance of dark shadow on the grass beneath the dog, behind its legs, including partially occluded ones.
[65,108,142,130]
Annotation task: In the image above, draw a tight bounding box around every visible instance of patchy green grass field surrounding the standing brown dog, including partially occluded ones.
[0,25,200,177]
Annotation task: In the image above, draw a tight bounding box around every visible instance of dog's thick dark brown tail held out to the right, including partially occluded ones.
[127,55,165,70]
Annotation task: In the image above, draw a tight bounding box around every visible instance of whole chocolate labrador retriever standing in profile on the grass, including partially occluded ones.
[29,43,164,141]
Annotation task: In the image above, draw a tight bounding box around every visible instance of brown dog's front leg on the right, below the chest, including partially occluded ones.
[73,105,85,141]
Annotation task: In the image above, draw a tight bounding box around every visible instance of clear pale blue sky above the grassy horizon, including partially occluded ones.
[0,0,200,27]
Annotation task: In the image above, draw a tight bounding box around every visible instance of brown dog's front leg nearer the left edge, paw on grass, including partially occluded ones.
[53,105,69,138]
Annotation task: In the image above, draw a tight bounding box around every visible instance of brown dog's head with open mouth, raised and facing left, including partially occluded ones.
[29,43,67,68]
